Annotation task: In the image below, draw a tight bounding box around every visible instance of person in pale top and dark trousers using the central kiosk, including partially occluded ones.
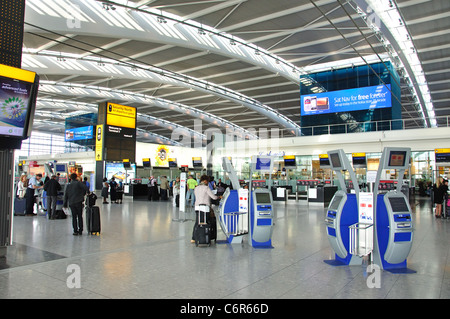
[191,175,222,243]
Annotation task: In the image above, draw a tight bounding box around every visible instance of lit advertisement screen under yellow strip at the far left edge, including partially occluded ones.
[0,77,33,136]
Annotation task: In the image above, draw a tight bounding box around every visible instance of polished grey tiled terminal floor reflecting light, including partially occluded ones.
[0,194,450,299]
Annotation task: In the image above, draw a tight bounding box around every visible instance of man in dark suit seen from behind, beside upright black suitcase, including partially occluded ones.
[63,173,89,236]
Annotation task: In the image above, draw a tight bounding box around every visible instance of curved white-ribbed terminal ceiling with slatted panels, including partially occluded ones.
[22,0,450,144]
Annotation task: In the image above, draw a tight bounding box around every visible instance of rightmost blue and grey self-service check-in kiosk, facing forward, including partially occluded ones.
[373,147,414,270]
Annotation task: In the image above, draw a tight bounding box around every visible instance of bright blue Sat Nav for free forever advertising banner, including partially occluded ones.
[301,84,392,116]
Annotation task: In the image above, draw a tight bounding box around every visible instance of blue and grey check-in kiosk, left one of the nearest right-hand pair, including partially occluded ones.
[325,150,362,265]
